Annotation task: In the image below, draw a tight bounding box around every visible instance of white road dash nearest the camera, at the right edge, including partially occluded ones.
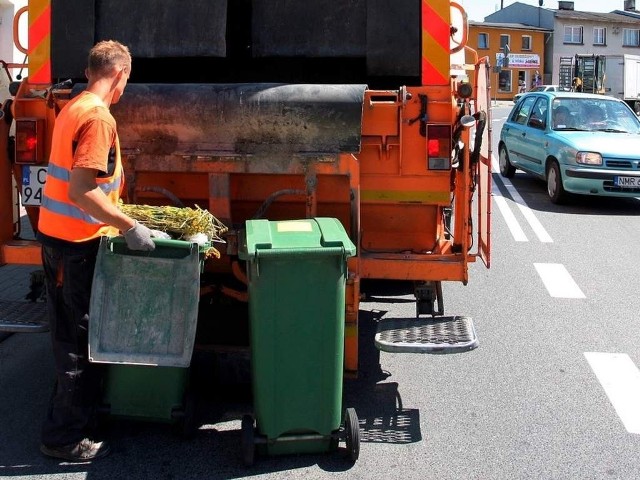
[584,352,640,434]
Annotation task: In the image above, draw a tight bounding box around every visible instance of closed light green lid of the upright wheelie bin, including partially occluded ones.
[238,217,356,260]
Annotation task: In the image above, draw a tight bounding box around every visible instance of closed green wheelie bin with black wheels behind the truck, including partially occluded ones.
[239,218,359,464]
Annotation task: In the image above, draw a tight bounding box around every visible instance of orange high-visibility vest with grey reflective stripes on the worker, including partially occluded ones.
[38,92,124,242]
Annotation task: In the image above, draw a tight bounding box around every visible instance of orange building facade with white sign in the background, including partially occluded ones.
[468,22,549,100]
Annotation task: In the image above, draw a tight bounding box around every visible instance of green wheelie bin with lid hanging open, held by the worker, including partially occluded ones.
[89,237,202,435]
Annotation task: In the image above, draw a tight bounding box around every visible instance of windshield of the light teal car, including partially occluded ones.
[551,97,640,134]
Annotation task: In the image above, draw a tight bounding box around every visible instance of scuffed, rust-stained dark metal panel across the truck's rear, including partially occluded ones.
[102,84,366,158]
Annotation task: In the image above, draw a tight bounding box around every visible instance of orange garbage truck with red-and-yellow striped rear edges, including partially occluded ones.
[0,0,491,454]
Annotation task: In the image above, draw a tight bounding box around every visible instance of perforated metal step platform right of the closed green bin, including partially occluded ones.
[375,316,478,353]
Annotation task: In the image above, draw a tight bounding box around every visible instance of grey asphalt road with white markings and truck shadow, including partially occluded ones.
[0,106,640,480]
